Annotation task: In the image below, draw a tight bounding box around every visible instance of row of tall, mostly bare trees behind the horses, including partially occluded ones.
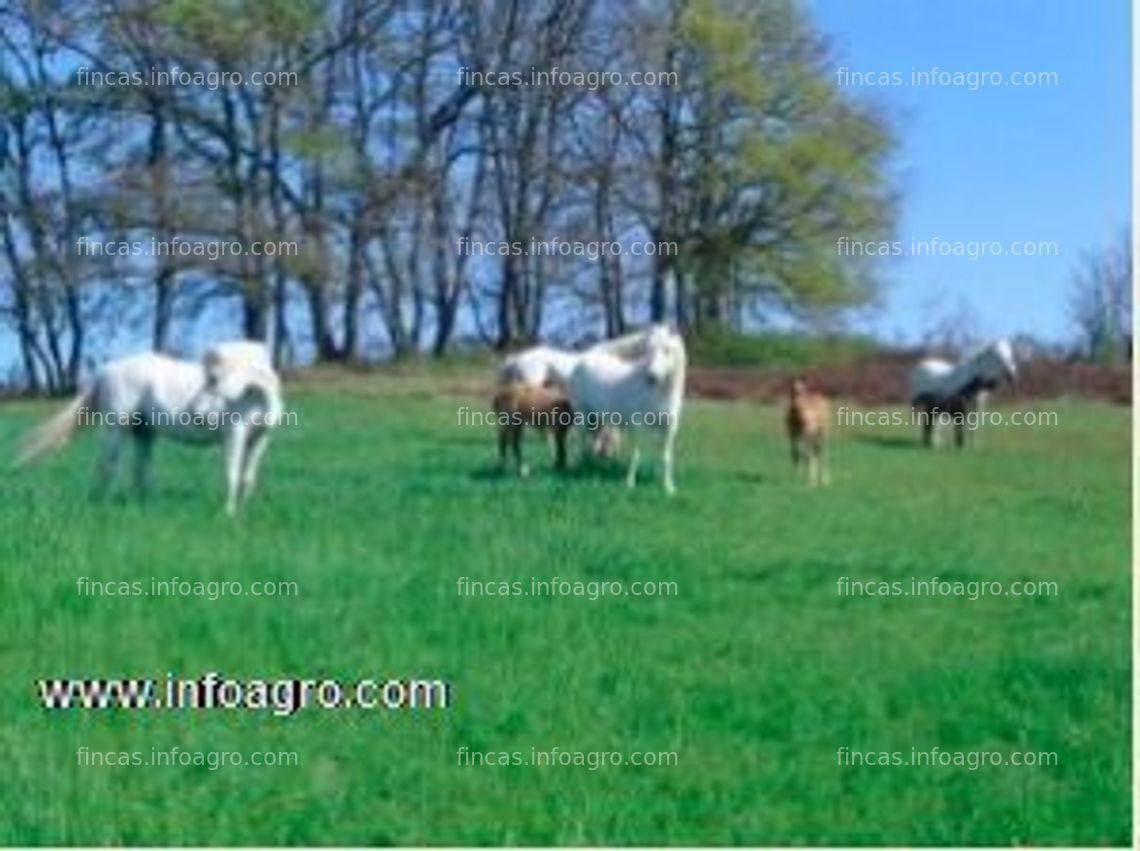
[0,0,893,391]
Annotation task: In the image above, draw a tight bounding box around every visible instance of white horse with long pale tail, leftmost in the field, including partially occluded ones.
[17,341,284,514]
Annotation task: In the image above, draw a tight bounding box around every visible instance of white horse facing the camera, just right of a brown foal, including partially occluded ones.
[568,325,687,494]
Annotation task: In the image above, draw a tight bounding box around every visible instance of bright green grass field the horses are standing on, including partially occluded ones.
[0,378,1131,845]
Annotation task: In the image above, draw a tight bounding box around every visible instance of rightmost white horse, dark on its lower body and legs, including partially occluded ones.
[911,339,1017,446]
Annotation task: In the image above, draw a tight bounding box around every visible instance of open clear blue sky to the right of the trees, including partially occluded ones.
[807,0,1132,340]
